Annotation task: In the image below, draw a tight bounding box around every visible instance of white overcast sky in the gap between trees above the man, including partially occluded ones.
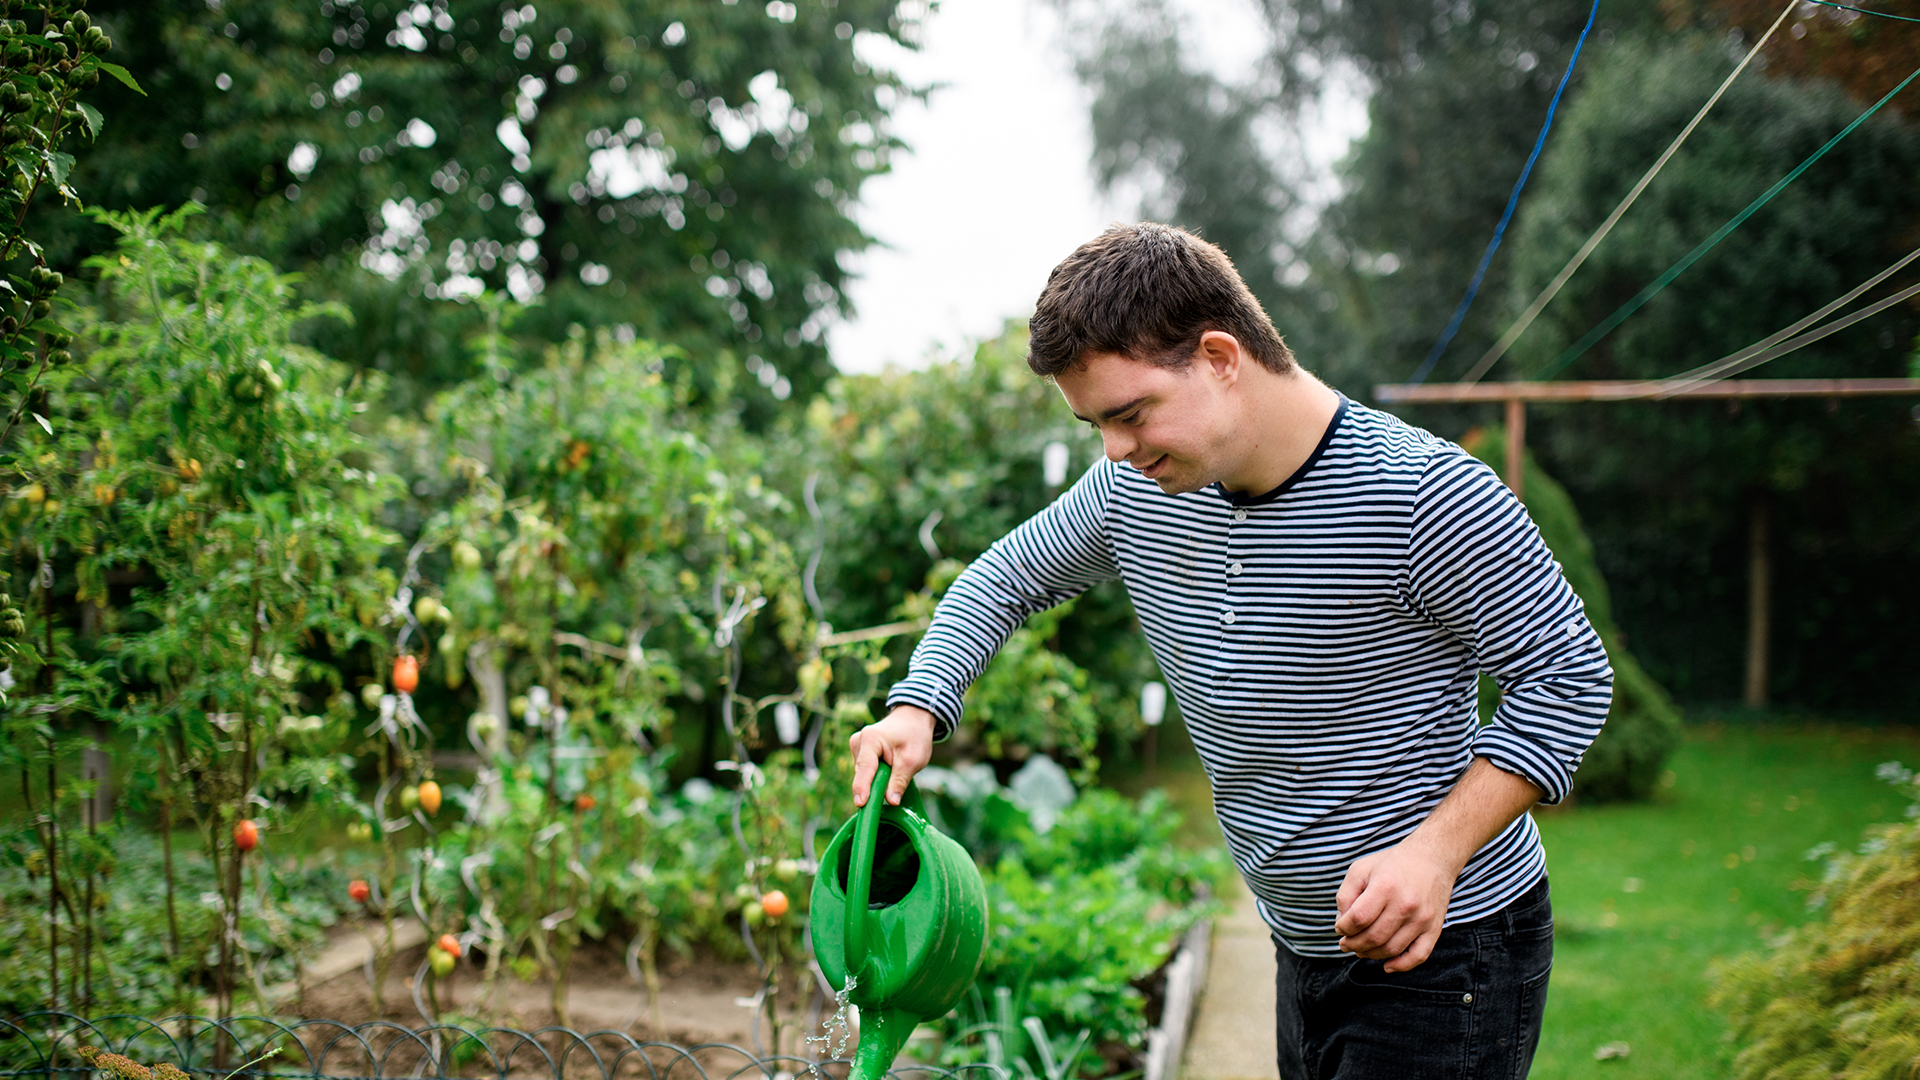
[828,0,1290,371]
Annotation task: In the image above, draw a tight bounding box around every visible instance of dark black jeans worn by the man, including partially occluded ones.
[1275,878,1553,1080]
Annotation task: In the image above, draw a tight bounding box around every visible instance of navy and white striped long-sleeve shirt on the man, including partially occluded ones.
[889,400,1613,955]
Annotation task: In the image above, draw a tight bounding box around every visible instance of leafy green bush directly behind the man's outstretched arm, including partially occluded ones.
[787,327,1158,767]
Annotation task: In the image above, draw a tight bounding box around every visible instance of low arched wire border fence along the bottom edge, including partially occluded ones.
[0,1013,1010,1080]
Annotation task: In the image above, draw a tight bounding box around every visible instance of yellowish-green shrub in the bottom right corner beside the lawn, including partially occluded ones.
[1713,763,1920,1080]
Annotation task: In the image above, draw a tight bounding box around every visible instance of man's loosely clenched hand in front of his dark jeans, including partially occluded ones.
[1332,838,1459,972]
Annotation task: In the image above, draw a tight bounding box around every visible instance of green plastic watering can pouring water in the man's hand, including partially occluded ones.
[810,761,987,1080]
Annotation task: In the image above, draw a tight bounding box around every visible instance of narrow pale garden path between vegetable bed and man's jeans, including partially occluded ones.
[1181,874,1279,1080]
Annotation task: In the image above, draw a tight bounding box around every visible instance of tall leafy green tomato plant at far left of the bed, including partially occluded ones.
[0,205,394,1001]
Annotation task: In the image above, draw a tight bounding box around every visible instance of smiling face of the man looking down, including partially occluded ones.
[1054,350,1236,494]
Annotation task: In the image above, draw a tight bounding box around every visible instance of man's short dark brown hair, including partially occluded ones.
[1027,221,1294,379]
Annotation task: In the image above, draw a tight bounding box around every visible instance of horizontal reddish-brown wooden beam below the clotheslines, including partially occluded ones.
[1373,379,1920,404]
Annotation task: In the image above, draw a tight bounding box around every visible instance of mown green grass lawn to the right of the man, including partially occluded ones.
[1532,721,1920,1080]
